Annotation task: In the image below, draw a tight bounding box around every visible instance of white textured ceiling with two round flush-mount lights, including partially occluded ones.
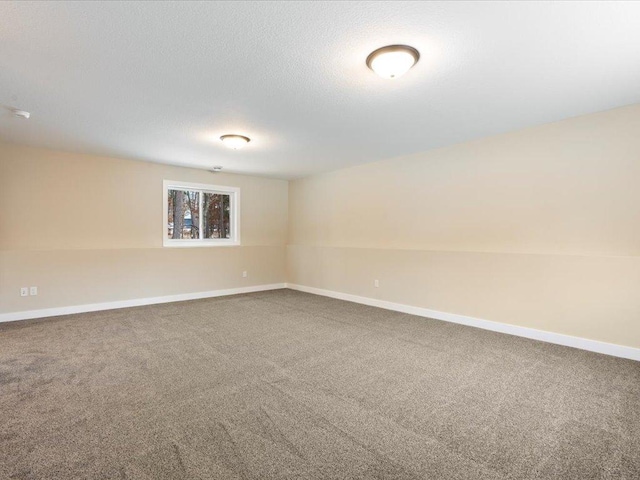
[0,2,640,178]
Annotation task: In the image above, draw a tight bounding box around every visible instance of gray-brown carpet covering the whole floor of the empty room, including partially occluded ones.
[0,290,640,480]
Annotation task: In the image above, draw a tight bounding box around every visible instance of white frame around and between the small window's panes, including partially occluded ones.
[162,180,240,247]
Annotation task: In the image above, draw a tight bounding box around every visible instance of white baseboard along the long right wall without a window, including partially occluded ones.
[286,283,640,361]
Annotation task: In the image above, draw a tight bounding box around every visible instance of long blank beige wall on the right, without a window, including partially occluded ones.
[287,105,640,347]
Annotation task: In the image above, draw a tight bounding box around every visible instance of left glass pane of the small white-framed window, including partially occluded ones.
[167,189,200,239]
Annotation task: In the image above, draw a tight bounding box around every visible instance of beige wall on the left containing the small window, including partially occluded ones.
[0,144,288,313]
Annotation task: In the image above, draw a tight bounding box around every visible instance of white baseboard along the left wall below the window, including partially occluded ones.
[0,283,286,322]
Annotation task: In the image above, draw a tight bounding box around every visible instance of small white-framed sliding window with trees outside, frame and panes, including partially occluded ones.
[162,180,240,247]
